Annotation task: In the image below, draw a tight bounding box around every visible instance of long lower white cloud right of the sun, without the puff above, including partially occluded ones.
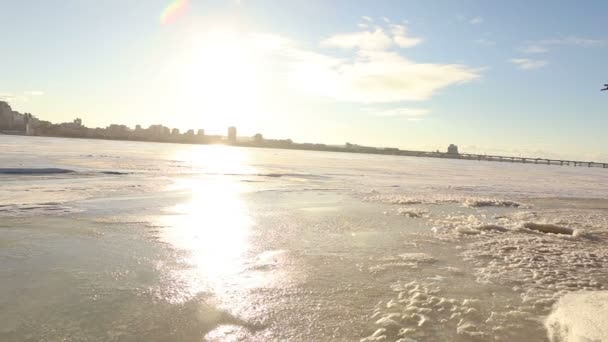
[290,46,479,103]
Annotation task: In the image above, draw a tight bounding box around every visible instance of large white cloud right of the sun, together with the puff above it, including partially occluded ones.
[286,25,480,103]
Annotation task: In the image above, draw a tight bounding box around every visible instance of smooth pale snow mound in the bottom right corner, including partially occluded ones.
[545,291,608,342]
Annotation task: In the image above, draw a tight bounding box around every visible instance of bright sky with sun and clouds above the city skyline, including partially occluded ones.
[0,0,608,161]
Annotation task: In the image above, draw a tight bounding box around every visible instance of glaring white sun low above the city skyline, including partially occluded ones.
[173,27,263,132]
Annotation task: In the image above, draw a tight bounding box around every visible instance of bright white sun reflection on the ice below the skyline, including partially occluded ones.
[160,147,252,299]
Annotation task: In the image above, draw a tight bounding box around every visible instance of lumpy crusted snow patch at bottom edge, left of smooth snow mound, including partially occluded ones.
[360,281,544,342]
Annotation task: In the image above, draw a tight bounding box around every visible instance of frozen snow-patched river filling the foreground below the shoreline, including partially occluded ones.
[0,135,608,342]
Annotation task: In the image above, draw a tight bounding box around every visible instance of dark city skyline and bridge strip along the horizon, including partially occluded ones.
[0,99,608,168]
